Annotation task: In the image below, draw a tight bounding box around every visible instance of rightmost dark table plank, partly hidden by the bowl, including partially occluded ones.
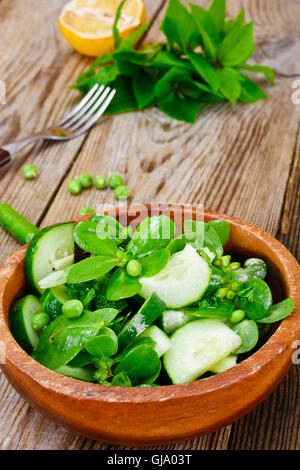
[230,120,300,450]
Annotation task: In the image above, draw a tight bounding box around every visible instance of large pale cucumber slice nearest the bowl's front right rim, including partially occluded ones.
[164,319,241,384]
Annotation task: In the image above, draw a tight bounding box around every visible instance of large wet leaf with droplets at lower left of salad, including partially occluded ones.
[32,309,105,370]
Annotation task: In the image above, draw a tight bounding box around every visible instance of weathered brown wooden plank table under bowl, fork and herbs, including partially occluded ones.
[0,0,300,450]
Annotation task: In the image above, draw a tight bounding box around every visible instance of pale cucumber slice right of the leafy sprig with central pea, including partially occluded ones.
[139,245,211,308]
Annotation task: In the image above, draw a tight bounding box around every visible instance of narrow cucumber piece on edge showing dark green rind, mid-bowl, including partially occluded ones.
[118,292,166,351]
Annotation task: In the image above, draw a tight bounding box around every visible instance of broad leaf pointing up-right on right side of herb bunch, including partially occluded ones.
[218,22,254,67]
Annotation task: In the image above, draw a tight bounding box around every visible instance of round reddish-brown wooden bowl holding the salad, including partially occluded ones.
[0,206,300,445]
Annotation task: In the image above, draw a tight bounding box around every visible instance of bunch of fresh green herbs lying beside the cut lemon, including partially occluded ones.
[71,0,274,123]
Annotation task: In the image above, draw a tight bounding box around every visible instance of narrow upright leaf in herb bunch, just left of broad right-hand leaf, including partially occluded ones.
[190,3,220,59]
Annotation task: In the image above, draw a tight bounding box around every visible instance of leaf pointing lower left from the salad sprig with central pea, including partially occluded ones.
[68,256,119,284]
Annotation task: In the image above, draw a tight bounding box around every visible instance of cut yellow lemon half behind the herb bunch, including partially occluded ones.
[58,0,146,57]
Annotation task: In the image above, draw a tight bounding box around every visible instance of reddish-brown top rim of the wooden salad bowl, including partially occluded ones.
[0,204,300,403]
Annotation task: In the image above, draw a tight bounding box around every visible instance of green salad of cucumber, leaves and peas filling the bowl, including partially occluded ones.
[10,214,294,387]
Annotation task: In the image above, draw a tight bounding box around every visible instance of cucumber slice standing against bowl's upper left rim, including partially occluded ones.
[25,222,75,293]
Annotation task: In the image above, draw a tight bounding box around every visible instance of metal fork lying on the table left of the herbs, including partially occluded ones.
[0,84,116,168]
